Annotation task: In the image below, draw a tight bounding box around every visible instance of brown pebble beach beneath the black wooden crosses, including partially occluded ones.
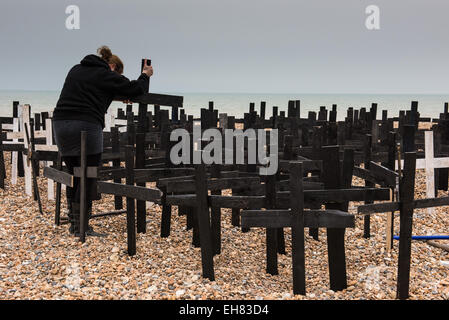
[0,153,449,300]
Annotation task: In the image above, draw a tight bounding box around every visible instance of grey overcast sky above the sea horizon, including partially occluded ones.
[0,0,449,94]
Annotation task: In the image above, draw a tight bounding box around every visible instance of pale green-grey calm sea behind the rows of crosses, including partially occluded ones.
[0,90,449,120]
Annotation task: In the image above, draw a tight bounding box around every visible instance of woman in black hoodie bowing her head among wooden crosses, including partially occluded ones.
[53,46,153,236]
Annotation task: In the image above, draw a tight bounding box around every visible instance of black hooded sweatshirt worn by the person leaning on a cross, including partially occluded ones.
[53,54,149,128]
